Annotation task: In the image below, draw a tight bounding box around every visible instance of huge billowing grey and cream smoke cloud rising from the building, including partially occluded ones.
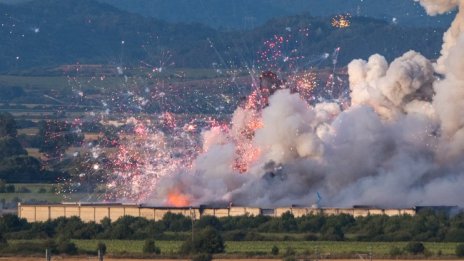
[147,0,464,207]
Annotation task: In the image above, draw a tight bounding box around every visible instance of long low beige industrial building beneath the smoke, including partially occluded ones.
[18,203,416,223]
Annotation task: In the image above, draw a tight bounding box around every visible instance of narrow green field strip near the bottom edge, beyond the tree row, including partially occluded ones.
[66,240,456,256]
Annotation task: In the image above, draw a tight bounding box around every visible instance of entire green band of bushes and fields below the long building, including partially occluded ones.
[0,211,464,259]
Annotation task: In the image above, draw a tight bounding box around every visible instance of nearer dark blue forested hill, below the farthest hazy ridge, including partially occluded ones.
[0,0,444,72]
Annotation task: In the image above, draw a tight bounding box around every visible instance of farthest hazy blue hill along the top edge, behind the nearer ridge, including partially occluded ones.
[96,0,454,29]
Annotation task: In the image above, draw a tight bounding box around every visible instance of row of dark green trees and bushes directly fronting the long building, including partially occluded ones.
[0,210,464,242]
